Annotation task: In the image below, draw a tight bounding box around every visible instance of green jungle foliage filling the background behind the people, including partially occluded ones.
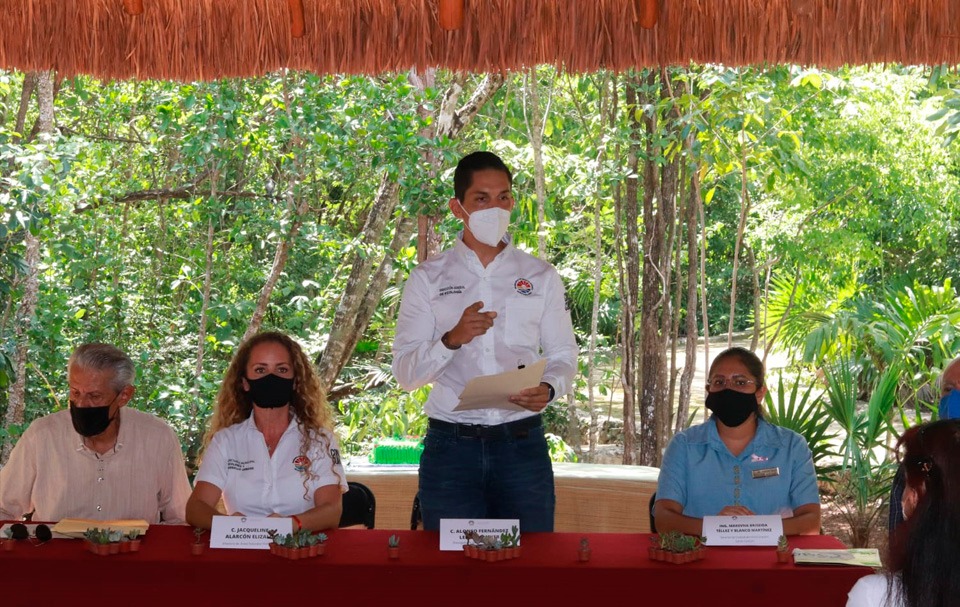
[0,66,960,508]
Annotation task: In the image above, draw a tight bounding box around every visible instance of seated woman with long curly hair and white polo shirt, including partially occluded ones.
[187,332,347,530]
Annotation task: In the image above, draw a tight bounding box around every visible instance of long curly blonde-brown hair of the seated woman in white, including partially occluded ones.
[203,331,339,489]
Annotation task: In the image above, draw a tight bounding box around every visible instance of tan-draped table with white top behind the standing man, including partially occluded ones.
[346,462,660,533]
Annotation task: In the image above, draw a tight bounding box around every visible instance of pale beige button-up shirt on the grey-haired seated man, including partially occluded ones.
[0,407,190,524]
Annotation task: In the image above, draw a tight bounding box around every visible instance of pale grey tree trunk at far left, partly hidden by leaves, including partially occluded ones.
[0,72,54,464]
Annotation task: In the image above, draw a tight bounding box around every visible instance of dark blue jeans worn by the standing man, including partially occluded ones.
[420,426,556,532]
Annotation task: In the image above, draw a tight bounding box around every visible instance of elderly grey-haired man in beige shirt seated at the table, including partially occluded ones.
[0,344,190,523]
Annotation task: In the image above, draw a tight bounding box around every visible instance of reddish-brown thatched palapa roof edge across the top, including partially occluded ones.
[0,0,960,80]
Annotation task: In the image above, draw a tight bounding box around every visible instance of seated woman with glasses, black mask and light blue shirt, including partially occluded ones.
[654,348,820,535]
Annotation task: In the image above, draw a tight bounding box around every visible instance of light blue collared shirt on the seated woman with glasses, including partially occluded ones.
[657,417,820,518]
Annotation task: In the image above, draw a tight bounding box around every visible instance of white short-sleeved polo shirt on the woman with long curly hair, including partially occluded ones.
[196,414,347,516]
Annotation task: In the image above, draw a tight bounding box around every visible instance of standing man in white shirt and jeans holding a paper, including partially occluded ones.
[393,152,578,531]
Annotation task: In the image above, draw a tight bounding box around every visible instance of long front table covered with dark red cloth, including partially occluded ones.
[0,526,870,607]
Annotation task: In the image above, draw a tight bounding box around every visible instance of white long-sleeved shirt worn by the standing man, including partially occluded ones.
[393,233,578,425]
